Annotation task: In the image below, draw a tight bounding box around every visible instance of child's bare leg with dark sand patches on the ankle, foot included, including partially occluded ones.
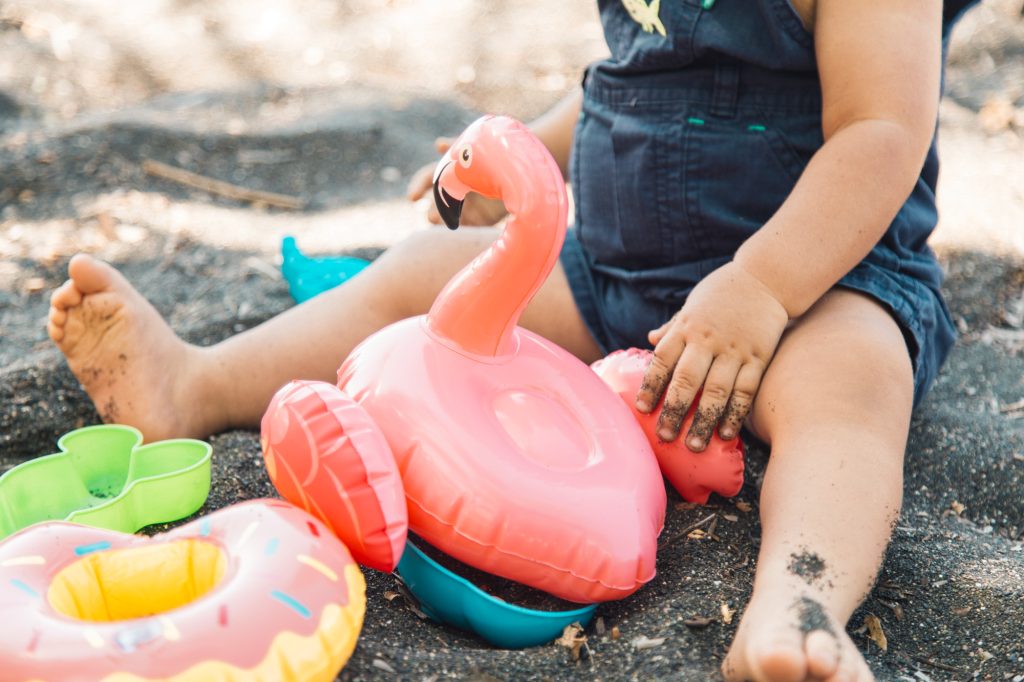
[722,289,913,681]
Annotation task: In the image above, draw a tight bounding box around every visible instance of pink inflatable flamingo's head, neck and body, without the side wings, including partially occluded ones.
[265,117,666,610]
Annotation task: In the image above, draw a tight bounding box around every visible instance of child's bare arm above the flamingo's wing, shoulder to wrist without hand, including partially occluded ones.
[735,0,942,317]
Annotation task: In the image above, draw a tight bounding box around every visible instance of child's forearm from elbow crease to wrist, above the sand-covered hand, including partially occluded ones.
[734,119,931,317]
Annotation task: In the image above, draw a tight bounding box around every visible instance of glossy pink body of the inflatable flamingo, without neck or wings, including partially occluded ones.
[338,316,666,603]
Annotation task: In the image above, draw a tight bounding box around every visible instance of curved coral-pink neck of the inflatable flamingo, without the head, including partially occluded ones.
[427,140,567,356]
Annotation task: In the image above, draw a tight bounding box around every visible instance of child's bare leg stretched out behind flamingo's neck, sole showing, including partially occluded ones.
[49,228,599,440]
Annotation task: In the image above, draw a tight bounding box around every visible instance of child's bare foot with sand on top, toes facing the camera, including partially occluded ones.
[722,586,874,682]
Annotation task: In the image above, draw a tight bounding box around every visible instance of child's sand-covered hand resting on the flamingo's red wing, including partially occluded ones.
[636,262,788,452]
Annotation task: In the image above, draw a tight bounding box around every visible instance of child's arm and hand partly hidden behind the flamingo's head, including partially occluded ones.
[407,87,583,225]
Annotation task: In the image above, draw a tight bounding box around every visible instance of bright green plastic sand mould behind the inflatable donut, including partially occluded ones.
[0,424,212,539]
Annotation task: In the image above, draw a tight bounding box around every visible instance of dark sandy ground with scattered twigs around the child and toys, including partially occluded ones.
[0,0,1024,682]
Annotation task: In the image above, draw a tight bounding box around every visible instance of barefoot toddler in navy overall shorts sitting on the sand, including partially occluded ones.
[49,0,970,681]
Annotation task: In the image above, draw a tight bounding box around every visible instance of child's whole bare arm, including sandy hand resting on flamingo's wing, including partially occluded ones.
[637,0,942,451]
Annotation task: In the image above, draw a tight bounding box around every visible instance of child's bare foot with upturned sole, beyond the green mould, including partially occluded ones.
[47,254,215,440]
